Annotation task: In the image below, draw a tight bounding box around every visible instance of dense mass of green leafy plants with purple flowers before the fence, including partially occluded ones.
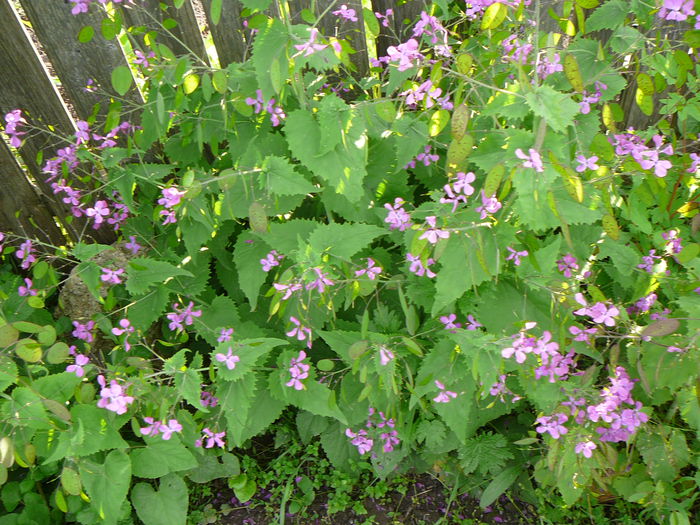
[0,0,700,525]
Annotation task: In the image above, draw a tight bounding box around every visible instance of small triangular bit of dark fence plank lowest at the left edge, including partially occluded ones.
[0,140,63,244]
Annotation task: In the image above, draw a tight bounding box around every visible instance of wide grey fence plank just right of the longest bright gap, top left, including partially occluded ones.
[20,0,142,119]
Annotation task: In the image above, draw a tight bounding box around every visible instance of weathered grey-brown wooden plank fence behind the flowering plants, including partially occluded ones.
[0,0,664,245]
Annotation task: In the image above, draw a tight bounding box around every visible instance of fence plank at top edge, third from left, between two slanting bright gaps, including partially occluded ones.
[122,0,209,64]
